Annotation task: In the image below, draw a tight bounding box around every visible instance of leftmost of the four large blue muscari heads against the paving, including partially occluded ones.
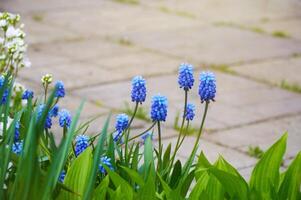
[131,76,146,103]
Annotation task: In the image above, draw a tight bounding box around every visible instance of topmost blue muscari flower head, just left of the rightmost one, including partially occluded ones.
[178,63,194,90]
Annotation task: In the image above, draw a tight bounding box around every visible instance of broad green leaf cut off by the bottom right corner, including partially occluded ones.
[278,152,301,200]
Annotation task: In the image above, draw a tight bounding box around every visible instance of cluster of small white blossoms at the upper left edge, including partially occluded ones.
[0,12,31,71]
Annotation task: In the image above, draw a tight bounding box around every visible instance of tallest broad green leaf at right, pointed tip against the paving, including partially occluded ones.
[250,133,287,198]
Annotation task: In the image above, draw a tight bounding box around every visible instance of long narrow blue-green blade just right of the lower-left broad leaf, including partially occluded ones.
[83,116,110,199]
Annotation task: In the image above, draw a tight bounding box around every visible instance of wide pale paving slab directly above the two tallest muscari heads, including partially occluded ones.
[121,26,301,64]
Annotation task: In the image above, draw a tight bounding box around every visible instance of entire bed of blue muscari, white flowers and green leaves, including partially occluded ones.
[0,13,301,200]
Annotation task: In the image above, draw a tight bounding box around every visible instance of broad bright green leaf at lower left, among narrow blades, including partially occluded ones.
[61,147,93,200]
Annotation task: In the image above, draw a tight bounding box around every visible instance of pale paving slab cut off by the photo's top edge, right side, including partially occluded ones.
[141,0,301,22]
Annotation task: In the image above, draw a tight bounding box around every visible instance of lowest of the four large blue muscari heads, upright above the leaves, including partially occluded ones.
[151,94,167,121]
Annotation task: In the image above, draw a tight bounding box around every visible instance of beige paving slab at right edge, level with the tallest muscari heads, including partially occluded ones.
[231,57,301,86]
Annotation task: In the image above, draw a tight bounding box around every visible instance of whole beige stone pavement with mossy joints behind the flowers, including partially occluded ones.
[0,0,301,178]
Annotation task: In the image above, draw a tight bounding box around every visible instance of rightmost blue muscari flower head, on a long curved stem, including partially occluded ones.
[199,72,216,103]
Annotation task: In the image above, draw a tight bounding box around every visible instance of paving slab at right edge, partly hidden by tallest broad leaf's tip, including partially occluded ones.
[204,115,301,158]
